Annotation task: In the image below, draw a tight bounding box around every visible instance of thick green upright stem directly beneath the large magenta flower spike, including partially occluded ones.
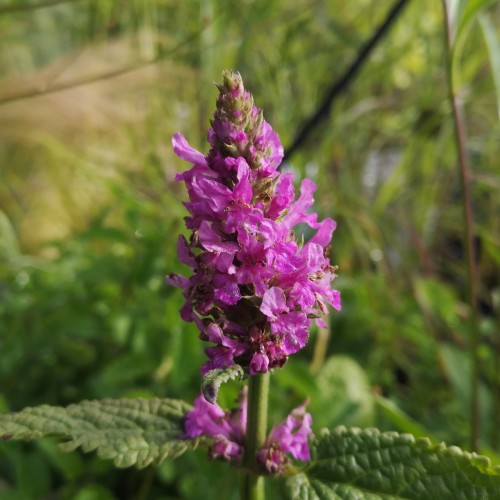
[241,372,269,500]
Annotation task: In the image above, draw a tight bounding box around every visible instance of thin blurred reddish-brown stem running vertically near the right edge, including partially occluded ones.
[443,0,480,451]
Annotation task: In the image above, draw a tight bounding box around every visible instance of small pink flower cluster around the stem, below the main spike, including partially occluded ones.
[184,388,312,474]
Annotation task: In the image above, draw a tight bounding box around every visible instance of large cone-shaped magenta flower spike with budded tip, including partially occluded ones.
[167,72,340,375]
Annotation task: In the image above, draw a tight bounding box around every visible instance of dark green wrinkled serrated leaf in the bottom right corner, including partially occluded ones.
[286,427,500,500]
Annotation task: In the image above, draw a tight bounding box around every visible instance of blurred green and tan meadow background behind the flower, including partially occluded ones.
[0,0,500,500]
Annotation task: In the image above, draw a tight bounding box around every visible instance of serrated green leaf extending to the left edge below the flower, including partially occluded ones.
[0,398,198,468]
